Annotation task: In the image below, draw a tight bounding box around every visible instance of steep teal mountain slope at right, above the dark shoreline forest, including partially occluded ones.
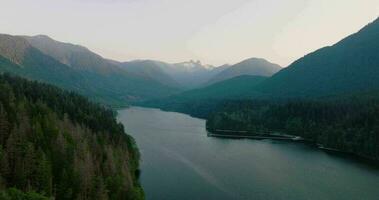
[256,19,379,97]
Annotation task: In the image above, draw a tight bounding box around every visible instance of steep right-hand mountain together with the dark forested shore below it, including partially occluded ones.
[203,19,379,161]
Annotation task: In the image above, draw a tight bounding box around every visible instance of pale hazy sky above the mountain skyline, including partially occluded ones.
[0,0,379,66]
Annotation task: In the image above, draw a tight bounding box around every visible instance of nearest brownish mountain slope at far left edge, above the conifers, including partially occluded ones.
[0,34,83,90]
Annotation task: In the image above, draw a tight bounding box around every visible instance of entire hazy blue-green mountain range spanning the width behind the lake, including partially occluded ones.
[0,17,379,111]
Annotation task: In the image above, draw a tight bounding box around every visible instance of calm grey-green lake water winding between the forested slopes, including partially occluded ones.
[118,107,379,200]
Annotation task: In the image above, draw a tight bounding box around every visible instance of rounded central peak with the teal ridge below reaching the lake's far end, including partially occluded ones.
[138,58,281,118]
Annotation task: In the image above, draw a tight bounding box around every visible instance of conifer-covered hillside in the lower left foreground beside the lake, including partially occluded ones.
[0,75,143,199]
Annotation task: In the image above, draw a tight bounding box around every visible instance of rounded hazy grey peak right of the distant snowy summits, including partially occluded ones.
[207,58,282,85]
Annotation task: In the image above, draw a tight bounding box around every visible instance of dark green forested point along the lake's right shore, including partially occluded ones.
[207,96,379,160]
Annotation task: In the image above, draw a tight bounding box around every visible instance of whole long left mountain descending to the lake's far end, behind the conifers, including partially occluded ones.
[0,34,178,106]
